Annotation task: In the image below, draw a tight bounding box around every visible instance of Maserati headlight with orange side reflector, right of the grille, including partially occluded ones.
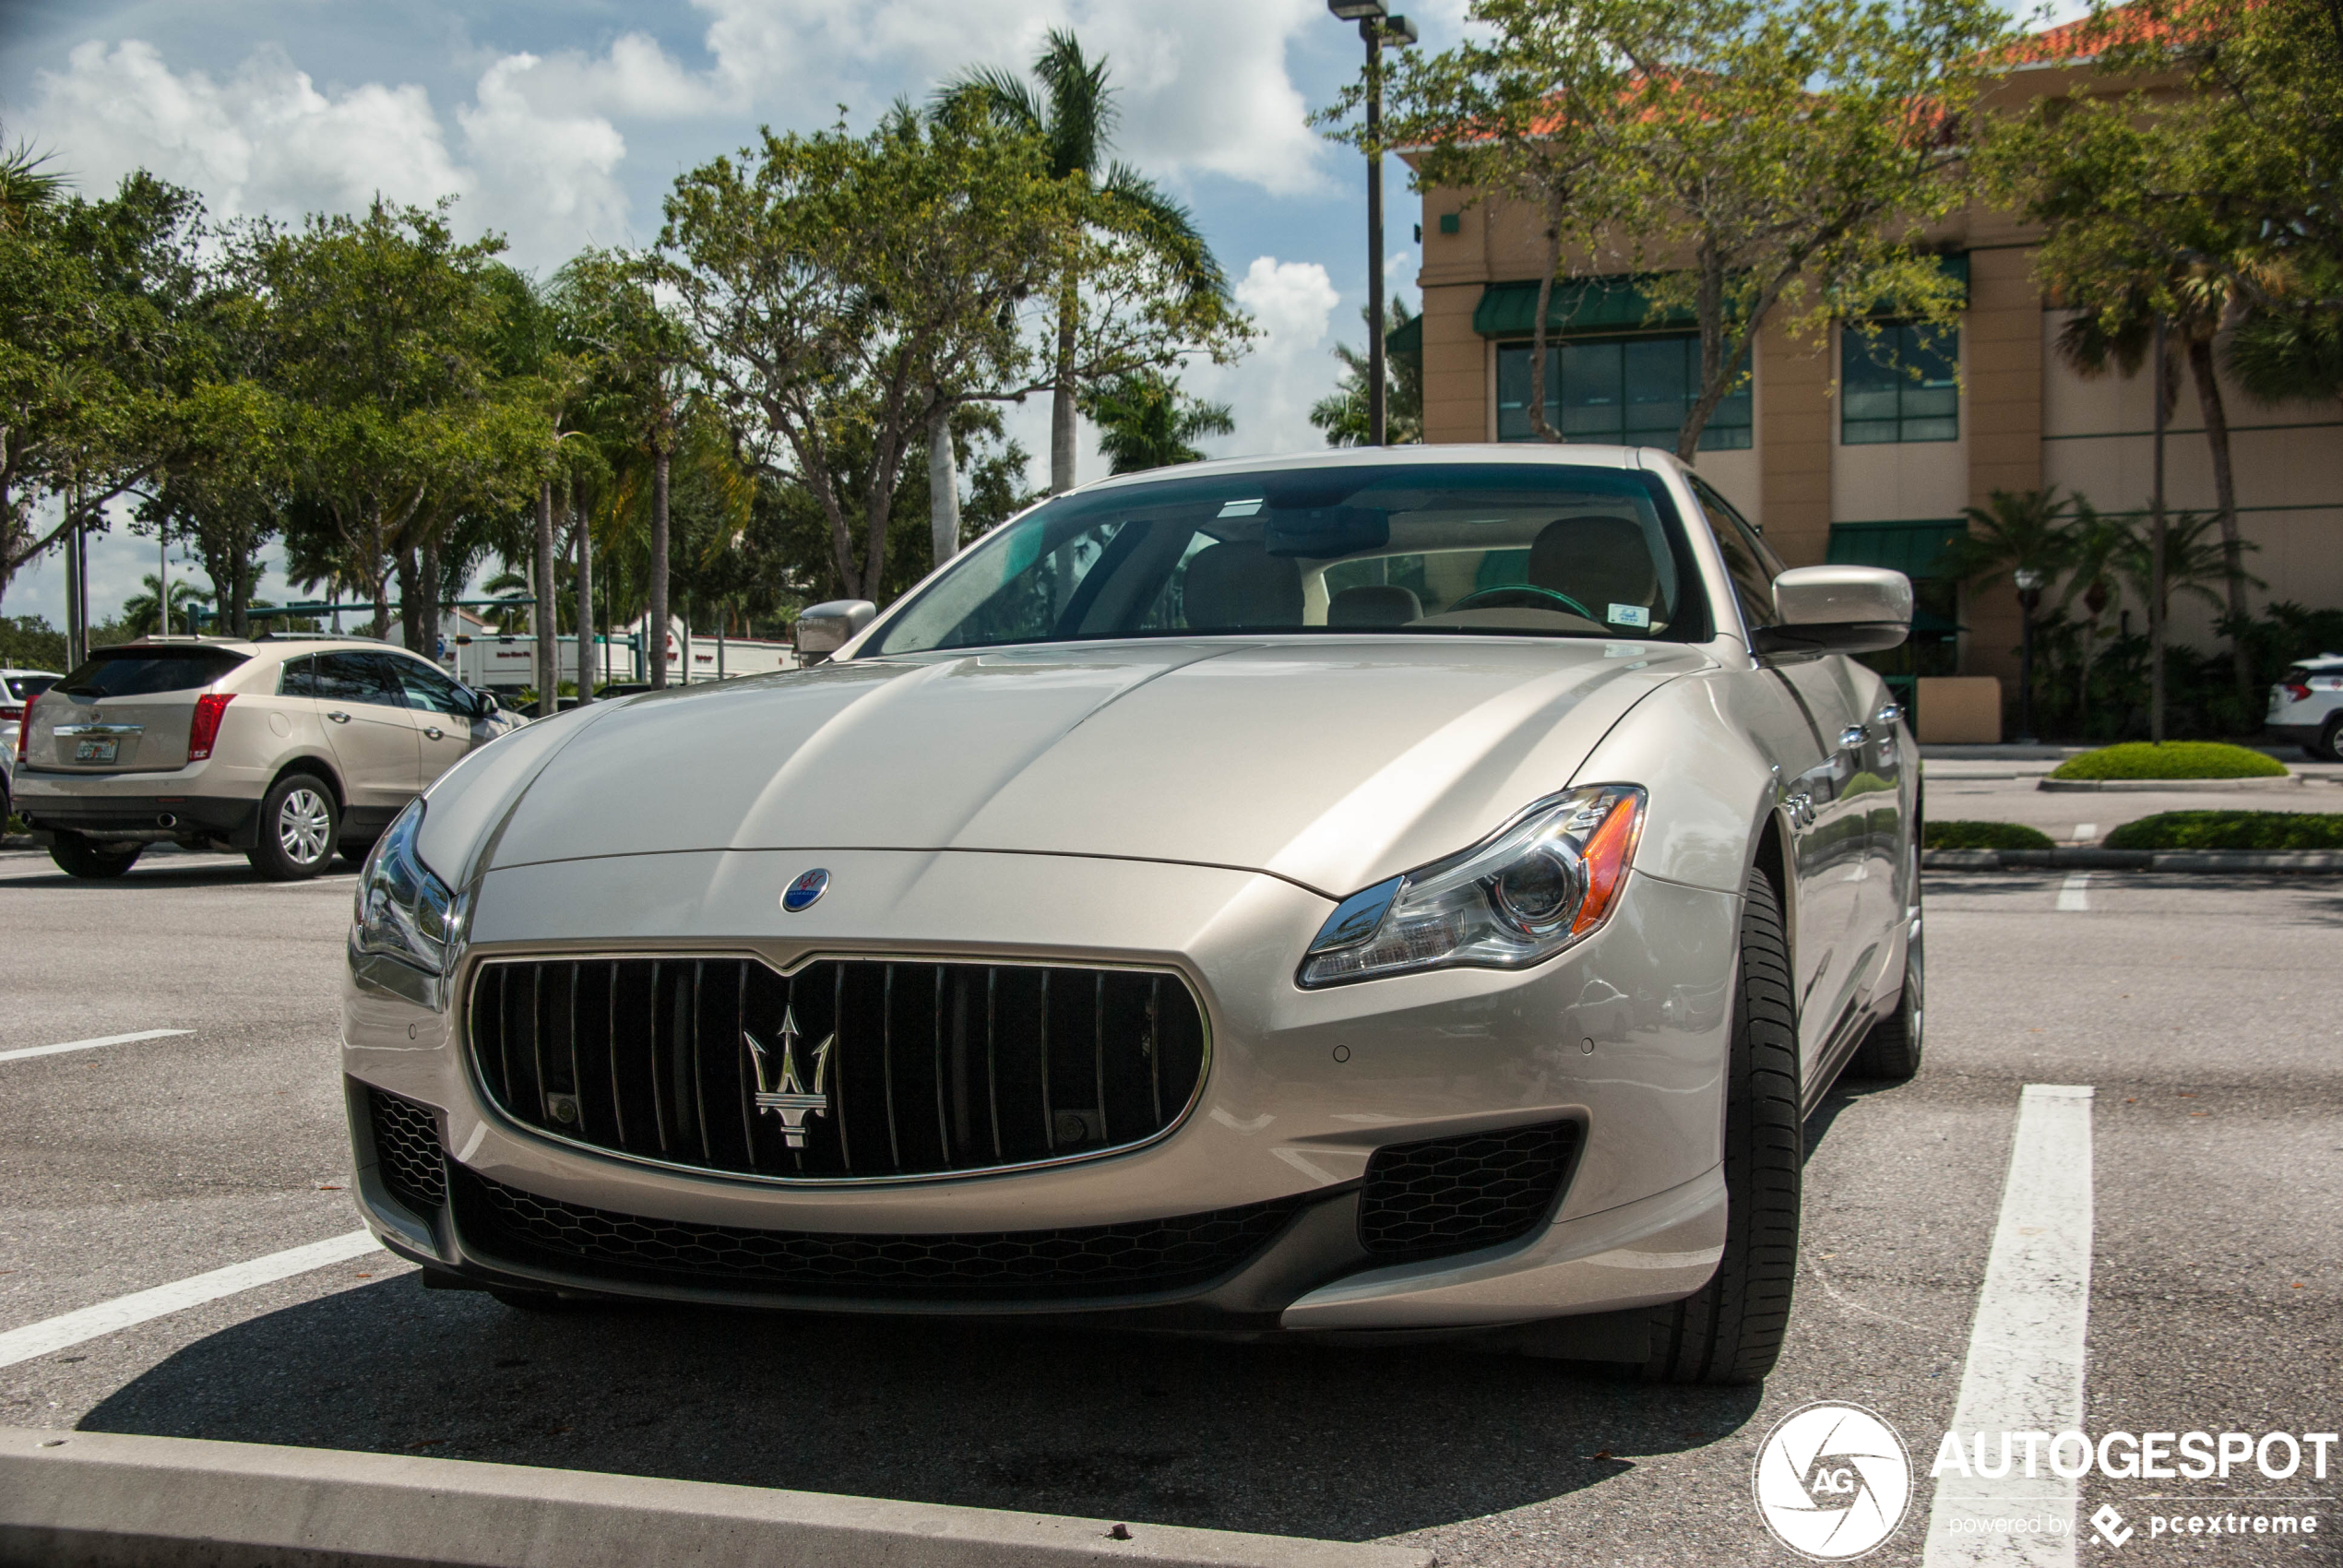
[1298,785,1645,987]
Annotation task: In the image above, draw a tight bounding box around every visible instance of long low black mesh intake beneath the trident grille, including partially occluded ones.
[455,1165,1307,1301]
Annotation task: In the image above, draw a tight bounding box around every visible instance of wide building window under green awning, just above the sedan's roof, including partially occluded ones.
[1497,333,1750,452]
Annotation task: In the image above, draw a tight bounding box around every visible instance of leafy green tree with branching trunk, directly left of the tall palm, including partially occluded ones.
[656,105,1087,598]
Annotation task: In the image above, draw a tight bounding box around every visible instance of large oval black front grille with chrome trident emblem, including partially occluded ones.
[469,958,1205,1182]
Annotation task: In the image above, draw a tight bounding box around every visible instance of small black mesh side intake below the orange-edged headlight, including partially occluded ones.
[1359,1123,1579,1259]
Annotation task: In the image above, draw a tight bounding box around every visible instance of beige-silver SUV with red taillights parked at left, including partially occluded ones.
[14,637,520,881]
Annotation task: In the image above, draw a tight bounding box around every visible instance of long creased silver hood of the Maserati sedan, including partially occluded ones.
[435,637,1706,896]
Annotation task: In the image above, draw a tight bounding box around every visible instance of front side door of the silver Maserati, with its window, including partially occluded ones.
[1694,481,1870,1074]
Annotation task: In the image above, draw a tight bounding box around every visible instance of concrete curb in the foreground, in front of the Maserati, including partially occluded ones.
[0,1428,1433,1568]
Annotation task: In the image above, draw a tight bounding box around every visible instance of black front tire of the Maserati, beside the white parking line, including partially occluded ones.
[1643,872,1806,1385]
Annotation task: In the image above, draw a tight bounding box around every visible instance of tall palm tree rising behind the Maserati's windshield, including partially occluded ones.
[937,28,1228,494]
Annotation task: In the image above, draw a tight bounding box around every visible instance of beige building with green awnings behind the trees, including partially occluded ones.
[1392,36,2343,721]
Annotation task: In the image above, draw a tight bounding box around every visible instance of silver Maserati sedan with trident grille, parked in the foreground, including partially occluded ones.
[344,447,1921,1383]
